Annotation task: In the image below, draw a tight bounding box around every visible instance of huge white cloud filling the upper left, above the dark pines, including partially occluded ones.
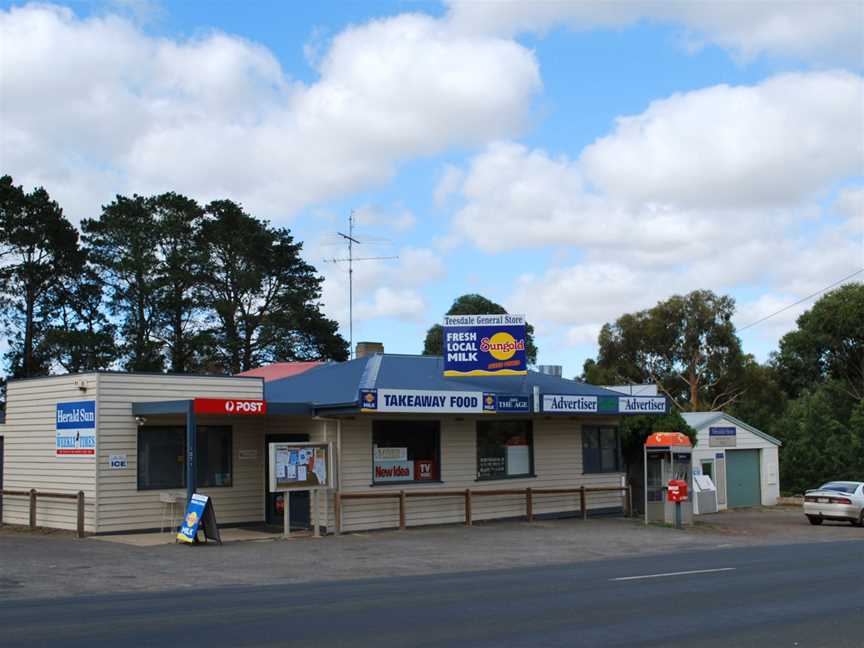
[0,5,540,221]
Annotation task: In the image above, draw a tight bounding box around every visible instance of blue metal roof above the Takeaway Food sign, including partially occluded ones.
[264,354,621,405]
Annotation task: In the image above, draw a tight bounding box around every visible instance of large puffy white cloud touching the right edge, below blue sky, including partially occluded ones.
[580,72,864,207]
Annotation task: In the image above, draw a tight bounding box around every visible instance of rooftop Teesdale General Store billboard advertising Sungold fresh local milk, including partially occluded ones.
[443,314,528,377]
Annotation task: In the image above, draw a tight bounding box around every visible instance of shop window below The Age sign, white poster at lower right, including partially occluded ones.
[477,421,534,480]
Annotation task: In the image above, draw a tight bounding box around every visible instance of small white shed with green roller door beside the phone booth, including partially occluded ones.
[681,412,780,510]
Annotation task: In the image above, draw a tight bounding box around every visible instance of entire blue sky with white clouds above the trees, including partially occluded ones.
[0,0,864,375]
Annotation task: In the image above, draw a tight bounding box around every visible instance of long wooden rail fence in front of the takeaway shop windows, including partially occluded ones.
[333,485,633,534]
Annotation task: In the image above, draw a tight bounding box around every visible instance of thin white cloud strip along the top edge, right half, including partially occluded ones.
[448,0,864,64]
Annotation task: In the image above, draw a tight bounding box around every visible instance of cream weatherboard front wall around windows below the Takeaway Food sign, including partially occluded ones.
[329,416,623,531]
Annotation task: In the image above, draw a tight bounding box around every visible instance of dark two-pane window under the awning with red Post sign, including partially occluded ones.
[138,425,233,490]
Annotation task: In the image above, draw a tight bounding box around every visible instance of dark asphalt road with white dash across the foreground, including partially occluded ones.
[0,541,864,648]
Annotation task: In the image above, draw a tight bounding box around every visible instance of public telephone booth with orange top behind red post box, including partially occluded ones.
[644,432,693,524]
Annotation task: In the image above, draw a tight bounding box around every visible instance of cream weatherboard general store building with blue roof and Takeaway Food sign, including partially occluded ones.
[2,353,668,533]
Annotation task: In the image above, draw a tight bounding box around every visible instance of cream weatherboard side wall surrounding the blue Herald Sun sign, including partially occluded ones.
[2,373,100,532]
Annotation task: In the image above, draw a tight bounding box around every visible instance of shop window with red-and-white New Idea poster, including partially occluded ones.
[372,421,441,484]
